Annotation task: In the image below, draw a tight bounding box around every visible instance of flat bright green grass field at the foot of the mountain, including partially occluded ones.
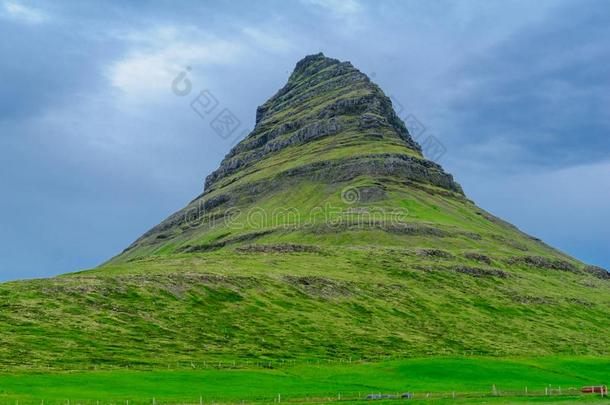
[0,357,610,404]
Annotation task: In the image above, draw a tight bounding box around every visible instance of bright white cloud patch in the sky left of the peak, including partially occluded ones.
[106,26,294,102]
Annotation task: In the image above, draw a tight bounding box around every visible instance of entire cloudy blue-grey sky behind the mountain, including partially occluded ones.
[0,0,610,280]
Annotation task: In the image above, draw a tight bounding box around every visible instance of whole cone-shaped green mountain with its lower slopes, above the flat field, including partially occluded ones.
[0,54,610,367]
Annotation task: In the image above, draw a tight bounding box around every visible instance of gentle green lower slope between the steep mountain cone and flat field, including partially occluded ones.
[0,241,610,368]
